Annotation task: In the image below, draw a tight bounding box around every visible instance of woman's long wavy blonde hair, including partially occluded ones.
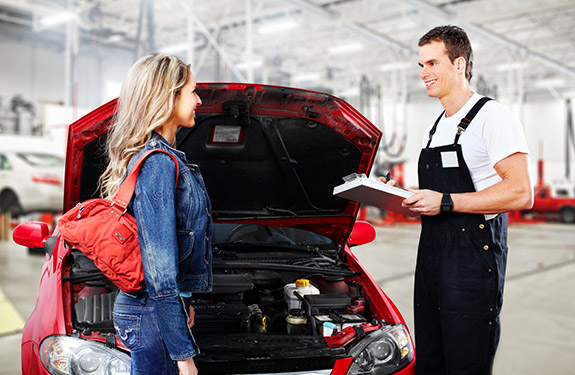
[100,54,190,199]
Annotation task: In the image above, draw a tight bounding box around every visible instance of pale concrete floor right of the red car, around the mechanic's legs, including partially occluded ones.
[354,223,575,375]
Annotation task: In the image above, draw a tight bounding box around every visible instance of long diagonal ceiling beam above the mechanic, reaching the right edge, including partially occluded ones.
[401,0,575,77]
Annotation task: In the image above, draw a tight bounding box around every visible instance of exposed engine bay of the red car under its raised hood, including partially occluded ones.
[65,225,392,373]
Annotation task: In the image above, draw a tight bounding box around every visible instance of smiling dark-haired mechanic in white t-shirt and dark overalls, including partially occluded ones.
[380,26,533,375]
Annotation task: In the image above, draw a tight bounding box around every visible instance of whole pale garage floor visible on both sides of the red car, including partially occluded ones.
[0,223,575,375]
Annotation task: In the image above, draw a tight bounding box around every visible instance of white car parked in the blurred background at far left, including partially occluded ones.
[0,143,65,218]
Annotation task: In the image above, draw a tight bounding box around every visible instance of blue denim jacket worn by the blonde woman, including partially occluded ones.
[128,133,212,360]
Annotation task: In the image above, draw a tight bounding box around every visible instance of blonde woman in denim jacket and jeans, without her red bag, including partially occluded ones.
[102,54,212,375]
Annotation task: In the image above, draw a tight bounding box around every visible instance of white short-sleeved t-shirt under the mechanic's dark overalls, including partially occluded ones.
[422,93,529,216]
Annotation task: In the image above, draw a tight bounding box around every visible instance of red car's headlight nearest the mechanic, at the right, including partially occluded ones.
[347,324,413,375]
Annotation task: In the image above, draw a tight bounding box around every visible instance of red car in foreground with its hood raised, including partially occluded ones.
[13,83,415,375]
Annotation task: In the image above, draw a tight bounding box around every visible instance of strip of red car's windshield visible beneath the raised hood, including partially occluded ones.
[213,223,335,248]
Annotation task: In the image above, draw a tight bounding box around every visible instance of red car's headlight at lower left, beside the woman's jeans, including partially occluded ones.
[40,336,130,375]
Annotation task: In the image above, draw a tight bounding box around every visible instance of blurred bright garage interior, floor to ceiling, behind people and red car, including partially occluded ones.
[0,0,575,375]
